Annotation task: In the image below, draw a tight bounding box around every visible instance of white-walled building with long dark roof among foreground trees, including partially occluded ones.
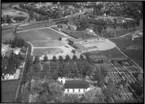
[58,78,90,94]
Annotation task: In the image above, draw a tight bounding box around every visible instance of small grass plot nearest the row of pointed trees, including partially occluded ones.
[33,48,63,56]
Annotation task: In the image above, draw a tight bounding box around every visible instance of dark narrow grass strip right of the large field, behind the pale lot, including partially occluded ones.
[61,30,96,39]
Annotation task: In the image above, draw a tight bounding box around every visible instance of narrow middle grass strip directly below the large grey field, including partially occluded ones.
[31,39,65,47]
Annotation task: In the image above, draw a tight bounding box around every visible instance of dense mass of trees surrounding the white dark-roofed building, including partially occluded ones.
[20,52,110,102]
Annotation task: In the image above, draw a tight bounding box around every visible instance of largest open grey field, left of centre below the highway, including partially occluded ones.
[18,28,63,42]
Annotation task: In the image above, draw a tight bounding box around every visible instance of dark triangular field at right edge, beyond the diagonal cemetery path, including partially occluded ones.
[111,37,143,67]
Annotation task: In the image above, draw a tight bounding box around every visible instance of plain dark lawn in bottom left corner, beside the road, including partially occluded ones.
[1,80,19,102]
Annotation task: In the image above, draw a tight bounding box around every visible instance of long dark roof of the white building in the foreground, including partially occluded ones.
[64,80,89,88]
